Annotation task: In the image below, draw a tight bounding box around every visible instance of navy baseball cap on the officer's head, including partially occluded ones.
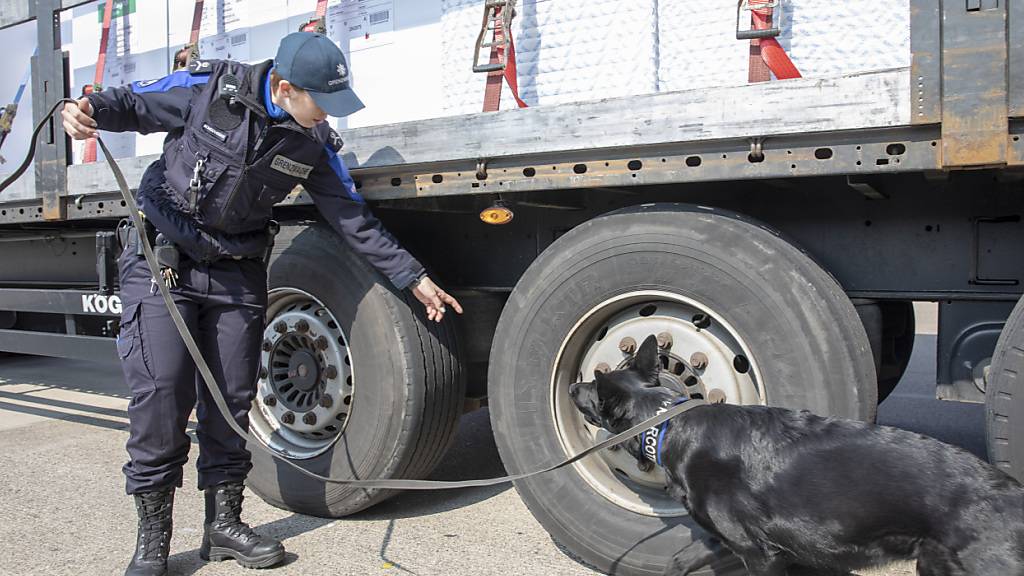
[273,32,366,117]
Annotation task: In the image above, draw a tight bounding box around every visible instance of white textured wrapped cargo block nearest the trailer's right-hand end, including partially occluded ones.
[658,0,910,91]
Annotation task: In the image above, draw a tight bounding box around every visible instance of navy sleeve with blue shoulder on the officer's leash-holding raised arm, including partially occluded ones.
[86,70,209,134]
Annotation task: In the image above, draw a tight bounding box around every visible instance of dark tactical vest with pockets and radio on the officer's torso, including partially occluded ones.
[164,60,341,234]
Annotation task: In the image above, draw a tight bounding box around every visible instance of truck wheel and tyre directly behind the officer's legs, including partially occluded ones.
[248,227,465,518]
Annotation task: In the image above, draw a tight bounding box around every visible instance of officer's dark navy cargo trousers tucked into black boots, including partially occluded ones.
[118,230,266,494]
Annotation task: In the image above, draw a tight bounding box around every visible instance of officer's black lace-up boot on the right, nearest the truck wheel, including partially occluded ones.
[199,482,285,568]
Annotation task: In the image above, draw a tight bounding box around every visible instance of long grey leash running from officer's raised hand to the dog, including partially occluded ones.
[0,98,707,483]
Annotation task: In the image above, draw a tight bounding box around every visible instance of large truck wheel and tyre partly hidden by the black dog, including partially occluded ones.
[488,204,877,576]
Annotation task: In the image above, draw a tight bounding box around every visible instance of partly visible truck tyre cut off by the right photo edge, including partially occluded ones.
[985,298,1024,482]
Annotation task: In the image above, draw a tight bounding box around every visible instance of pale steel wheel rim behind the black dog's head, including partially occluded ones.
[550,291,766,518]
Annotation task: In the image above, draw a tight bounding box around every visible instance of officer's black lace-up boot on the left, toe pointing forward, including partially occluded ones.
[125,487,174,576]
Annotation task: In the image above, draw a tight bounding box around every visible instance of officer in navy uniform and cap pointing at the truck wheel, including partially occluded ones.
[62,32,462,576]
